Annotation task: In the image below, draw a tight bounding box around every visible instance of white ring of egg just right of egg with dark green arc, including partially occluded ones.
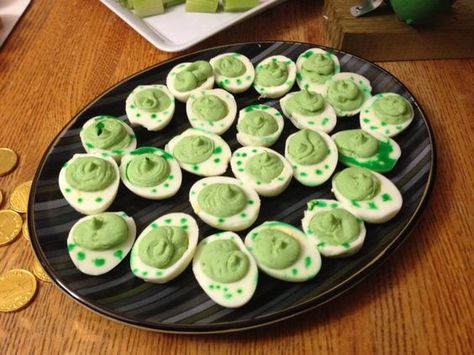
[165,128,232,176]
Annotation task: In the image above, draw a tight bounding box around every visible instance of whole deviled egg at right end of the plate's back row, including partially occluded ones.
[296,48,341,94]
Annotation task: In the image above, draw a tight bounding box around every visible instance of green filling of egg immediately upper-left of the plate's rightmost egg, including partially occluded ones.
[327,79,365,113]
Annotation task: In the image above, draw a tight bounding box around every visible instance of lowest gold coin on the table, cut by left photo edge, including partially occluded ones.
[0,269,37,312]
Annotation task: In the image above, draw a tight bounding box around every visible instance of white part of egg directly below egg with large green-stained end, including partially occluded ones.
[332,171,403,224]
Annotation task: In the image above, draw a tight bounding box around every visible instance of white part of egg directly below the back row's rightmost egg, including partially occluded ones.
[280,92,337,133]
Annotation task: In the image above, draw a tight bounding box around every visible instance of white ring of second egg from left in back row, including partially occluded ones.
[209,52,255,94]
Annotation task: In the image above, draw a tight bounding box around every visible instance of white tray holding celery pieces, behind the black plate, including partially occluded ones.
[100,0,285,52]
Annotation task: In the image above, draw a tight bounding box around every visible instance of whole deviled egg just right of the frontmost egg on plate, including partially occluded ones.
[245,221,321,282]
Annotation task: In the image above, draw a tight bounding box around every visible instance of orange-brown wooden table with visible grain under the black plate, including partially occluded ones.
[0,0,474,354]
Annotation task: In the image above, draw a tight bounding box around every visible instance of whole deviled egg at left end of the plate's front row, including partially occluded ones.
[67,212,137,276]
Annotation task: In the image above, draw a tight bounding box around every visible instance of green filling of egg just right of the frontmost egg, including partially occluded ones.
[252,228,301,270]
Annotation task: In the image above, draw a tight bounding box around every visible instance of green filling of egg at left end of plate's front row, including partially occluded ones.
[72,213,128,250]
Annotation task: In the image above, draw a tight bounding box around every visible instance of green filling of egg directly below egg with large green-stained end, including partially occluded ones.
[334,167,380,201]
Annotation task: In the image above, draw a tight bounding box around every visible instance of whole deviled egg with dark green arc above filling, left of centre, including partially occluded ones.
[120,147,182,200]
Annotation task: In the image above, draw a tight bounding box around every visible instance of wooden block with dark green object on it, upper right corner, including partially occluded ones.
[323,0,474,61]
